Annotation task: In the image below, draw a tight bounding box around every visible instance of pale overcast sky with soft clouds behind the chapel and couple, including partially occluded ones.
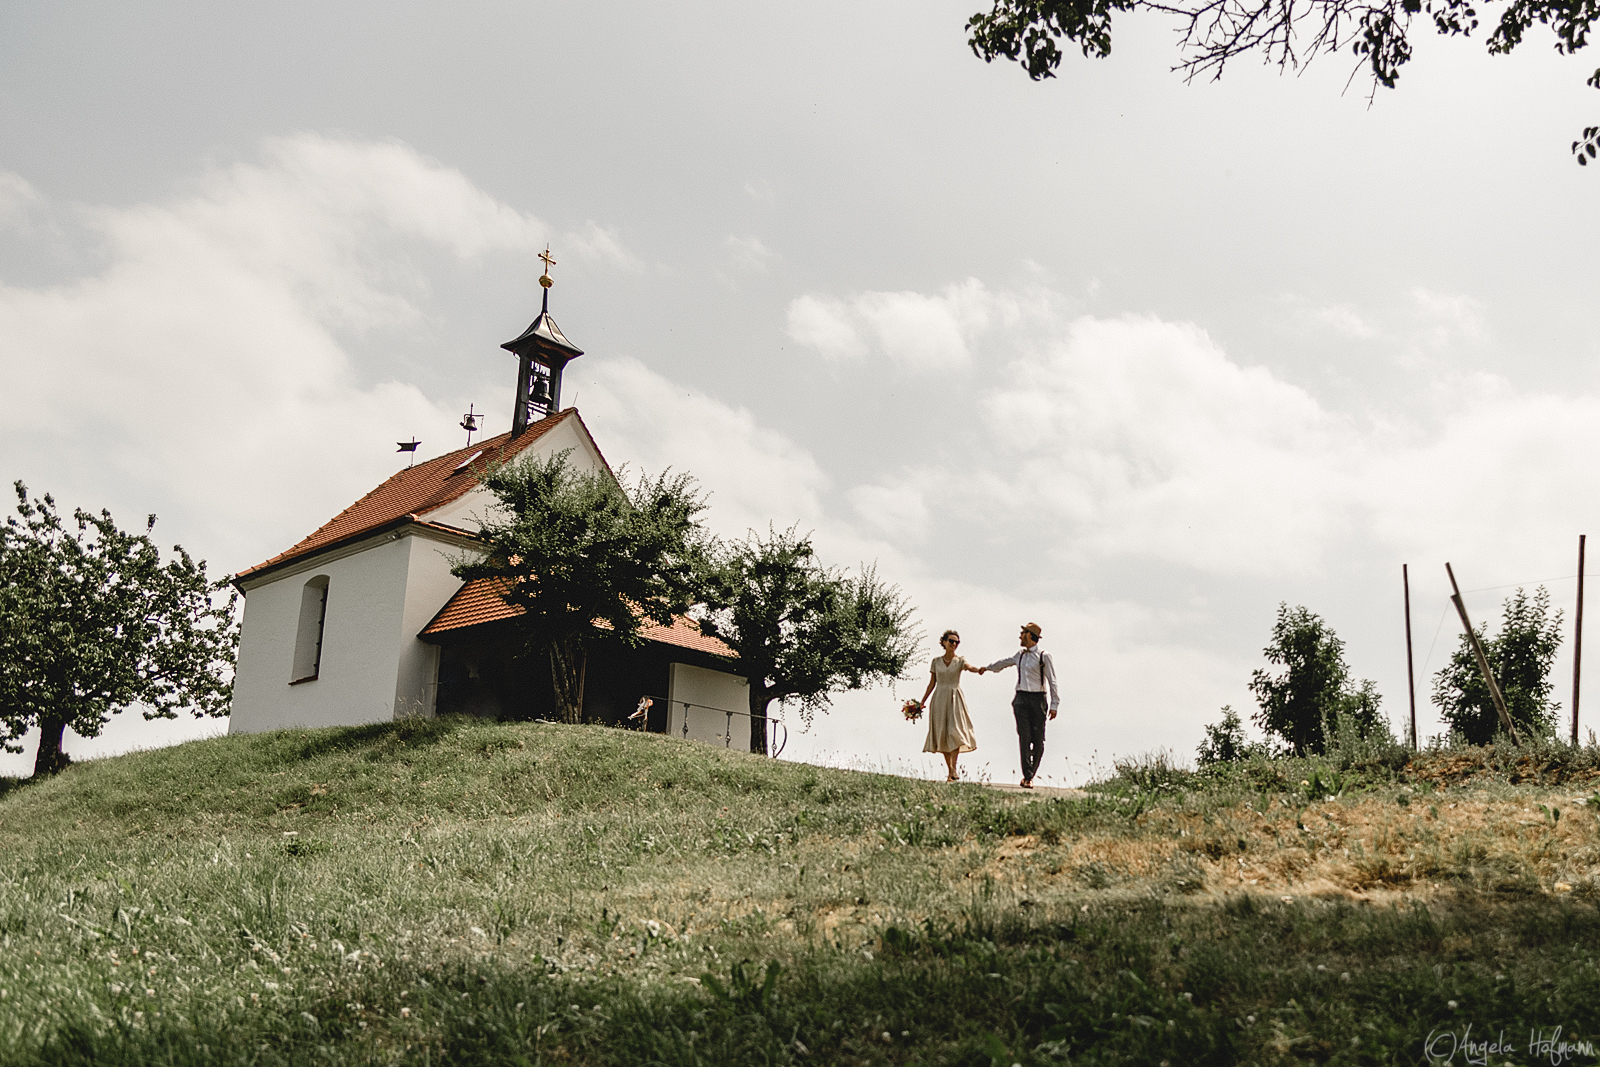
[0,0,1600,782]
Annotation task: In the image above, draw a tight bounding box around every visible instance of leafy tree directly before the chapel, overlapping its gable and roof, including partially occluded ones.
[451,451,709,723]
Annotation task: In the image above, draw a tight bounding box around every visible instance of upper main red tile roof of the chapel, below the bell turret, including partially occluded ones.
[234,408,578,582]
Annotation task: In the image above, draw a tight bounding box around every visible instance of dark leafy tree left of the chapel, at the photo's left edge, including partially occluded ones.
[0,482,238,776]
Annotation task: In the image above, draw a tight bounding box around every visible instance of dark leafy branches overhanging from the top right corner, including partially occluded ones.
[966,0,1600,165]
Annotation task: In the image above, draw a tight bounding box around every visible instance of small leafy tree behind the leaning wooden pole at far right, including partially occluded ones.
[1434,585,1562,744]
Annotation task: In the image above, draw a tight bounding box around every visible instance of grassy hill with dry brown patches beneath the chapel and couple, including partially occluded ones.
[0,720,1600,1067]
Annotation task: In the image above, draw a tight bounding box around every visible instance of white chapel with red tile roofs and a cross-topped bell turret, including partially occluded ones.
[229,267,749,749]
